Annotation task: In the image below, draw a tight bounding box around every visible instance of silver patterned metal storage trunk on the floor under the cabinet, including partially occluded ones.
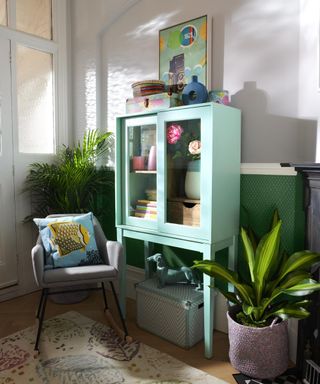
[136,278,203,348]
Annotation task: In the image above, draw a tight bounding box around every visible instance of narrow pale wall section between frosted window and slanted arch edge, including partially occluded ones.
[70,0,135,139]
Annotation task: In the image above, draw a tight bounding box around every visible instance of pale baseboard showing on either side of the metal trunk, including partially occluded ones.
[127,265,228,333]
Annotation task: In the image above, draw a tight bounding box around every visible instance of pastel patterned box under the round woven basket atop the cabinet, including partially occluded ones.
[126,92,182,113]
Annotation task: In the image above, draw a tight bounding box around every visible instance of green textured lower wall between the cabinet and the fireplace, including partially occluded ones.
[240,175,305,254]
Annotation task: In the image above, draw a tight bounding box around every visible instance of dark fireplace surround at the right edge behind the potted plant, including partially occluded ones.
[282,163,320,384]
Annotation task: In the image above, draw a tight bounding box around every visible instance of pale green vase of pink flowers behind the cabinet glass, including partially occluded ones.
[167,124,201,199]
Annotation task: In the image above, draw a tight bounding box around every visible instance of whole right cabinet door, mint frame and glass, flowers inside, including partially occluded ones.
[158,103,212,237]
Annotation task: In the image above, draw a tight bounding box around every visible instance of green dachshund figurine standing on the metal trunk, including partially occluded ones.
[147,253,202,290]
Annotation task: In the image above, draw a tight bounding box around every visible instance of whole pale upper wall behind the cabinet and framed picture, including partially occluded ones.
[71,0,319,163]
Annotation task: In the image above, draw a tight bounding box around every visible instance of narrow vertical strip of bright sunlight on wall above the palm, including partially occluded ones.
[85,63,97,130]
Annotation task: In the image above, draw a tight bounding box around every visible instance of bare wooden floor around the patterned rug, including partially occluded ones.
[0,292,236,383]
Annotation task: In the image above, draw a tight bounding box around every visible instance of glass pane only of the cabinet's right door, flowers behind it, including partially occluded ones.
[165,118,201,227]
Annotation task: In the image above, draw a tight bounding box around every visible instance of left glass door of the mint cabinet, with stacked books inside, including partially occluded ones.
[124,116,158,227]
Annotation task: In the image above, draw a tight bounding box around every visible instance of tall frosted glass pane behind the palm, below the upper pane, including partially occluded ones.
[16,45,55,153]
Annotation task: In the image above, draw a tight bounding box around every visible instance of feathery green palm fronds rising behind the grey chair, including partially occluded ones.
[24,130,114,220]
